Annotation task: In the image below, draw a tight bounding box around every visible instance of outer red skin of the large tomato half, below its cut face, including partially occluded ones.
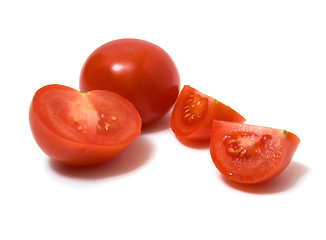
[29,85,141,166]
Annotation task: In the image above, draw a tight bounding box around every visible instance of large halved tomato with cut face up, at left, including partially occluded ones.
[29,84,141,166]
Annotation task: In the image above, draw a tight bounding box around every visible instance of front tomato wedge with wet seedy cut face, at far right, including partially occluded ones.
[210,121,300,183]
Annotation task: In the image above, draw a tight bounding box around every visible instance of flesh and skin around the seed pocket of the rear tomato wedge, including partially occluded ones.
[170,85,246,141]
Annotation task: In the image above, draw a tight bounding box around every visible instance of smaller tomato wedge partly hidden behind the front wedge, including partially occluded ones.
[170,85,246,141]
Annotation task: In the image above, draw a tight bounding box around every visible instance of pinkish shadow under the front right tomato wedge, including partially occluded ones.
[220,162,310,194]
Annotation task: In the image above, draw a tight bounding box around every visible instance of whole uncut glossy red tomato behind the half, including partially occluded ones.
[79,39,180,126]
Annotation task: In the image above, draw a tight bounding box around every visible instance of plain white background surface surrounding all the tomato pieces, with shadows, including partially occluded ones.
[0,0,326,240]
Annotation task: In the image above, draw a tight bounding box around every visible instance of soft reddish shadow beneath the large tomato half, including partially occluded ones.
[49,136,153,180]
